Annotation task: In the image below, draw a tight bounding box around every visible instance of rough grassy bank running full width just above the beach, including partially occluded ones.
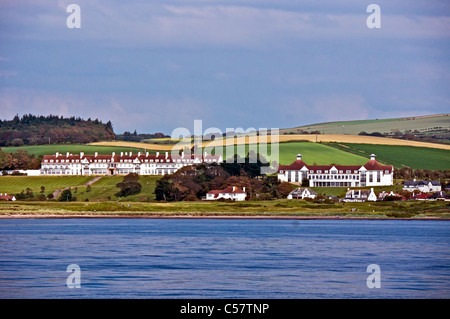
[0,199,450,219]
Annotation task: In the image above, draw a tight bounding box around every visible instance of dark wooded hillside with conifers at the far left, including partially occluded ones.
[0,114,115,147]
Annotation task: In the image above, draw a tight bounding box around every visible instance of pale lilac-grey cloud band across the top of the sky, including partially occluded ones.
[0,0,450,48]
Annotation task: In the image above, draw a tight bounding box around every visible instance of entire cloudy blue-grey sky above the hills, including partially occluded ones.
[0,0,450,135]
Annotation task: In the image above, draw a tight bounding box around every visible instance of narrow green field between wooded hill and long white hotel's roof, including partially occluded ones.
[2,144,149,156]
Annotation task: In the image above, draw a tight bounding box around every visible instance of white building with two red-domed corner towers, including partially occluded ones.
[278,154,394,187]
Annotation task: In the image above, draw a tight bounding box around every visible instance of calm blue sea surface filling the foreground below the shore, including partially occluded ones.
[0,219,450,299]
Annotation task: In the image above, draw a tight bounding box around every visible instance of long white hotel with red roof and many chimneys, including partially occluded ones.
[39,152,222,175]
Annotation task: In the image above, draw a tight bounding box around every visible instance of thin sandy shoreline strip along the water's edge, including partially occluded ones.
[0,213,450,221]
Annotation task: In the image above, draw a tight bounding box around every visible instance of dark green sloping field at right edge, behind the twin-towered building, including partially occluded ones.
[328,143,450,170]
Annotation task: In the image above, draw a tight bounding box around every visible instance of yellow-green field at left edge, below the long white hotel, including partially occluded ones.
[0,176,94,195]
